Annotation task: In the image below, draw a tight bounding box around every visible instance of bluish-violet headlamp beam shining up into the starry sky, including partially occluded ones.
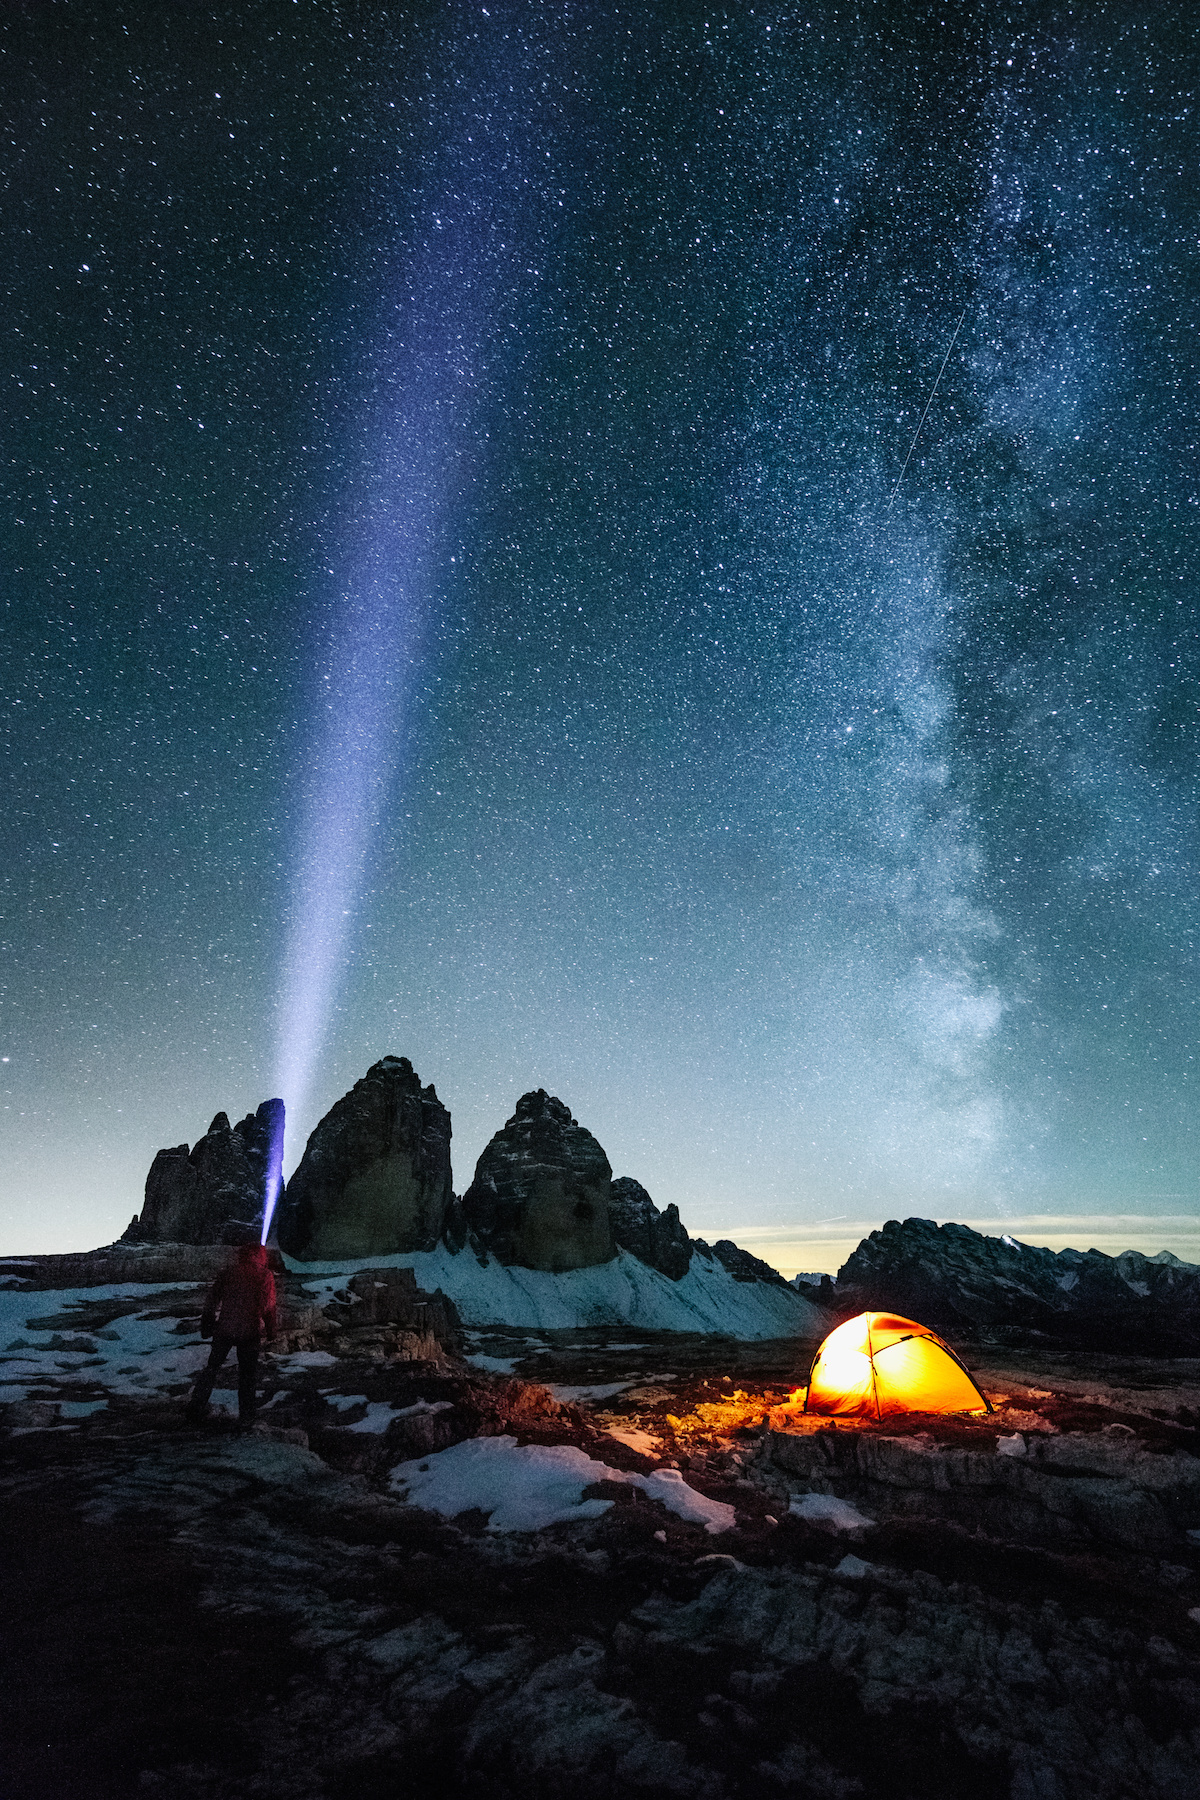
[264,9,561,1166]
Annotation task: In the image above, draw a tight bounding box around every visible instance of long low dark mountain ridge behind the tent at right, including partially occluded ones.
[835,1219,1200,1354]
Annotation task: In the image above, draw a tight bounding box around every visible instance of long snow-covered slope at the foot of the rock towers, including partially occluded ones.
[284,1244,829,1339]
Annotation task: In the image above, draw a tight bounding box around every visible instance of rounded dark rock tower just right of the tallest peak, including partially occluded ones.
[462,1087,615,1274]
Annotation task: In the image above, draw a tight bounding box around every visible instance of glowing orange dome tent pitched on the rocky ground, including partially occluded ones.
[804,1312,991,1418]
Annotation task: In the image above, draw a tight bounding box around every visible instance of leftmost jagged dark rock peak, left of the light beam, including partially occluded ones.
[124,1100,284,1244]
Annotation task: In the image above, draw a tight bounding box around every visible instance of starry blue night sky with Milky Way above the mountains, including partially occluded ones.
[0,0,1200,1265]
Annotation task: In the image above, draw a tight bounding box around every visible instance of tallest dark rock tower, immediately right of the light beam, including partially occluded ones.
[275,1057,453,1262]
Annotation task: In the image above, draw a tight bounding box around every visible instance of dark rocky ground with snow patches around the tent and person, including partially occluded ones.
[0,1283,1200,1800]
